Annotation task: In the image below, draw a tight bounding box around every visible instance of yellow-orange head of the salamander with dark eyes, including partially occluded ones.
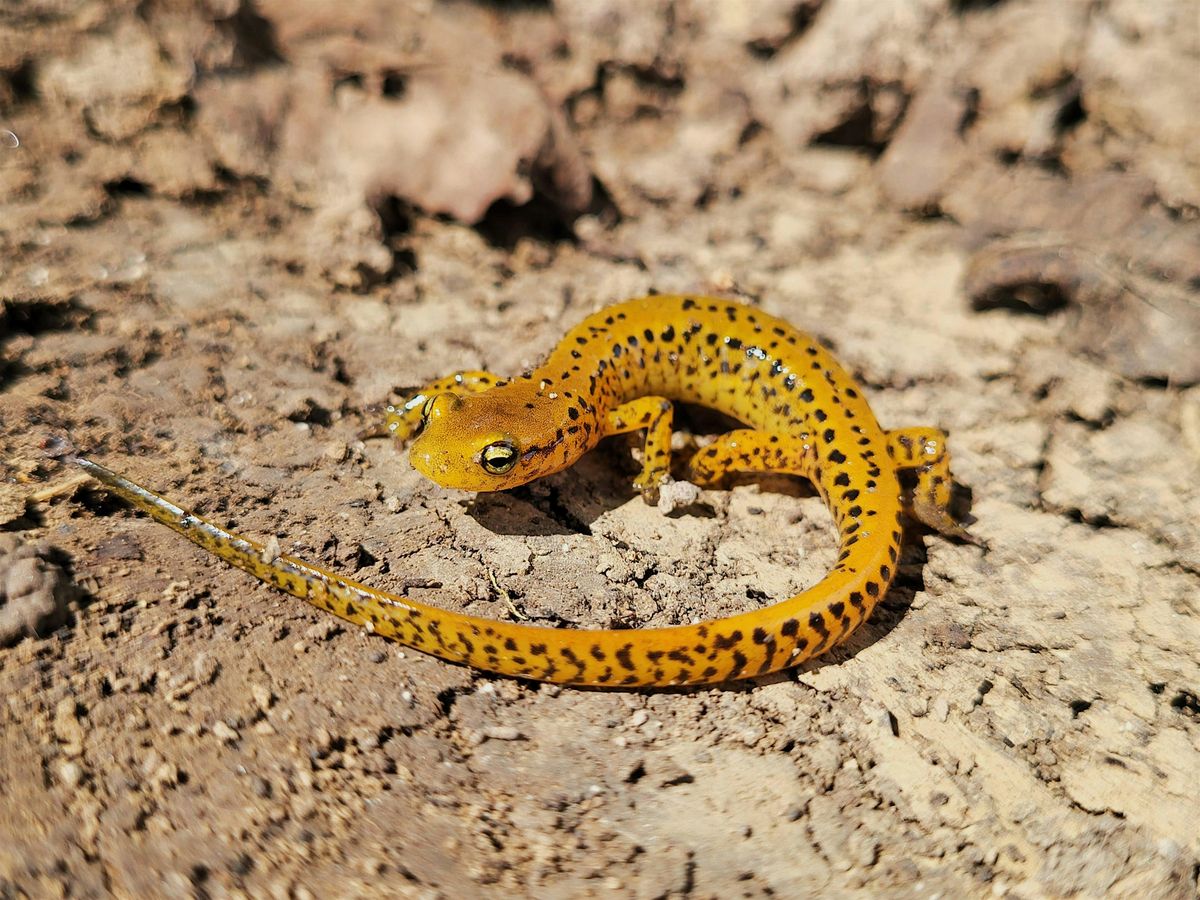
[408,384,594,491]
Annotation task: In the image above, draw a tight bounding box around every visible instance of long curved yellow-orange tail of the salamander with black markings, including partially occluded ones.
[68,457,900,686]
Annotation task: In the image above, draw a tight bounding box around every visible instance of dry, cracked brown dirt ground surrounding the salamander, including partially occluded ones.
[0,0,1200,898]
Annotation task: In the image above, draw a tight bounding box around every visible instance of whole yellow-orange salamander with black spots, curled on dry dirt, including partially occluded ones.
[76,296,970,686]
